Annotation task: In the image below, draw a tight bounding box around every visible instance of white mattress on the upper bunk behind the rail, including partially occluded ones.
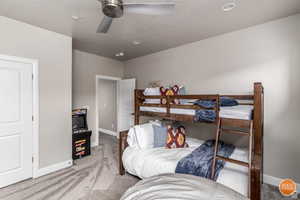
[140,105,253,120]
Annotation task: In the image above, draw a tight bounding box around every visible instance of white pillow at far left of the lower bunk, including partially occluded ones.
[127,123,154,149]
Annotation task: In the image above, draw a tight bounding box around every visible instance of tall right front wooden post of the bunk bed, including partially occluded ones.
[250,83,264,200]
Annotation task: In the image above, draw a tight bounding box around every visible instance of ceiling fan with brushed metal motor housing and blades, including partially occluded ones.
[97,0,175,33]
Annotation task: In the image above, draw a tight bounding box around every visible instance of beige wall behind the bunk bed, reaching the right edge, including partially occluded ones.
[125,15,300,182]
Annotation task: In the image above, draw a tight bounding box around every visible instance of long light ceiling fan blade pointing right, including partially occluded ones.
[124,2,175,15]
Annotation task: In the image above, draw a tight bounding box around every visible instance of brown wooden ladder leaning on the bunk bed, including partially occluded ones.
[211,118,253,196]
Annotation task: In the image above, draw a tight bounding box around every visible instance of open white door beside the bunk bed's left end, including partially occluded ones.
[118,79,136,131]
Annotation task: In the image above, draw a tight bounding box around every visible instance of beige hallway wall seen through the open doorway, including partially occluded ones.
[98,79,117,132]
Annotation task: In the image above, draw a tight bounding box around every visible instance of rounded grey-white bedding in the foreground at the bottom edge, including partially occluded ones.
[121,174,248,200]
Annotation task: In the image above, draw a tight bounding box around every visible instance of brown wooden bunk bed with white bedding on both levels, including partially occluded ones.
[119,83,264,200]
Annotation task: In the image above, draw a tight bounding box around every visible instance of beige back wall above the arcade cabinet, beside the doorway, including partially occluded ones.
[73,50,124,143]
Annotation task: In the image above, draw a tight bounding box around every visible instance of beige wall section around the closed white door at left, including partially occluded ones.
[0,17,72,168]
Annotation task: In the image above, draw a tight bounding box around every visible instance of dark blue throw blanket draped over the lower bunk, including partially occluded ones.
[175,140,235,181]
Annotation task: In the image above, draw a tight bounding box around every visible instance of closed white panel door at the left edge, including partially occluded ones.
[0,56,33,188]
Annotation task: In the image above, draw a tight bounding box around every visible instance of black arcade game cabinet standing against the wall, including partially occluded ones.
[72,109,92,160]
